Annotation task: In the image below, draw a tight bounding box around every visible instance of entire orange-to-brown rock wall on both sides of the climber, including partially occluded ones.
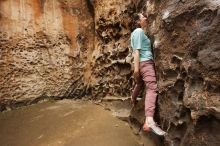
[0,0,220,146]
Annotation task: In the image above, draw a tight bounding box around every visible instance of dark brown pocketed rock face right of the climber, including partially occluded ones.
[133,0,220,146]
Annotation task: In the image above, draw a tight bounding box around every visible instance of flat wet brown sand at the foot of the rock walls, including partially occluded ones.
[0,100,153,146]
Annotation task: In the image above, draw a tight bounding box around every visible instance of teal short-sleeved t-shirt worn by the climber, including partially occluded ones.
[131,28,153,62]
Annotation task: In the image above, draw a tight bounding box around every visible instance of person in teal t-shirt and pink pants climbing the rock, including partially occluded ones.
[131,13,166,136]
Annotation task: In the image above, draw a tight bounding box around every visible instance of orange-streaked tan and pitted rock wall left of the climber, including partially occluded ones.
[0,0,136,109]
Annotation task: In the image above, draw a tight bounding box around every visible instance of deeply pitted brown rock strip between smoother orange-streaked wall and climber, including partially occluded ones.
[91,0,133,97]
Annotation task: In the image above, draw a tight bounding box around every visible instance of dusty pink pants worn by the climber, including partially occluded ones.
[132,60,157,117]
